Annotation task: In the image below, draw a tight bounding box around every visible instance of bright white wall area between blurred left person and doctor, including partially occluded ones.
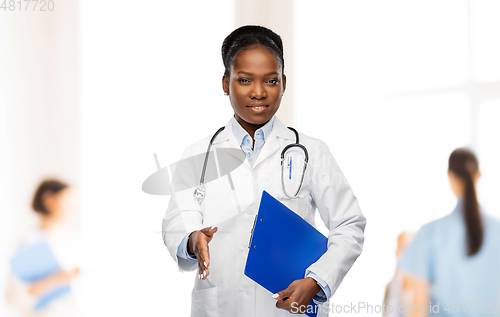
[81,1,234,316]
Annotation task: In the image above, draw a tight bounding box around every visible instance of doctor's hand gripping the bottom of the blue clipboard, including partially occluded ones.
[273,277,321,314]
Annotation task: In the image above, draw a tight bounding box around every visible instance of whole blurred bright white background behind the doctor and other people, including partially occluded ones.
[0,0,500,316]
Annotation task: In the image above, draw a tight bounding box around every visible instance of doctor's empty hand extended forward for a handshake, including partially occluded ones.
[188,227,217,280]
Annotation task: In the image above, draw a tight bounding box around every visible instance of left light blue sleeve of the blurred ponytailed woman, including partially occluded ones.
[398,225,433,281]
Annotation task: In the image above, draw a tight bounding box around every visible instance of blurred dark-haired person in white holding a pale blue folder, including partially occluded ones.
[6,179,80,317]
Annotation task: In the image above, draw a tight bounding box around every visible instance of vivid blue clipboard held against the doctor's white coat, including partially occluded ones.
[245,191,328,316]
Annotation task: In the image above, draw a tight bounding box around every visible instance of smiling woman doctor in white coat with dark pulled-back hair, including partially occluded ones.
[163,25,366,317]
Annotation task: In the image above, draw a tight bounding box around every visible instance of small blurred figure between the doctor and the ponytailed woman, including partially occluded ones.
[382,231,413,317]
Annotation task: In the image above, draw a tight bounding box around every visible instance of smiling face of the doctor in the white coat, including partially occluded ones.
[222,45,286,130]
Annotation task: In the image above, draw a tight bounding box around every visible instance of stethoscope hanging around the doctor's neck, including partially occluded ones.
[193,127,309,204]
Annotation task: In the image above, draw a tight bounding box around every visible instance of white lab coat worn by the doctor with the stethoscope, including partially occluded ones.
[163,118,366,317]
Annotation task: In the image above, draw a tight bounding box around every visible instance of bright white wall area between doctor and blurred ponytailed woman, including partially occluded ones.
[292,0,500,315]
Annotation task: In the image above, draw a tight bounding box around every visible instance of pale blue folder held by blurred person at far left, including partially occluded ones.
[10,237,71,311]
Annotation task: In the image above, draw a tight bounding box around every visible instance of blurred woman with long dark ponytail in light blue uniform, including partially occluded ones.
[400,148,500,316]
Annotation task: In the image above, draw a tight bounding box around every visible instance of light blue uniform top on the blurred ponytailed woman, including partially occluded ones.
[400,200,500,316]
